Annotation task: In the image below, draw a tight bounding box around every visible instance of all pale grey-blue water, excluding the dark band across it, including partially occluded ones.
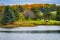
[0,26,60,40]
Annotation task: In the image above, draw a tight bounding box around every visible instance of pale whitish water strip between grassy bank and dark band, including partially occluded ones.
[0,26,60,31]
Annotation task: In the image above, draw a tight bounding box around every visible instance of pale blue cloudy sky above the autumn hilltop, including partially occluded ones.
[0,0,60,5]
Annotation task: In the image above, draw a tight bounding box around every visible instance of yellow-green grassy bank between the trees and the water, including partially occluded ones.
[0,20,60,28]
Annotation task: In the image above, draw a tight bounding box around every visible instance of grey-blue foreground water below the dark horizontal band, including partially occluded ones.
[0,32,60,40]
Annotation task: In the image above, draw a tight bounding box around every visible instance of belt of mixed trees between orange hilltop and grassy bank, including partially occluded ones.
[1,4,60,24]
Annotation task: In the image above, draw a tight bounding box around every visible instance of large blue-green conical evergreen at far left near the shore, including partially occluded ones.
[2,6,15,24]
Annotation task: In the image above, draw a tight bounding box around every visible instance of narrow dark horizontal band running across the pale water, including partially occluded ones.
[0,30,60,33]
